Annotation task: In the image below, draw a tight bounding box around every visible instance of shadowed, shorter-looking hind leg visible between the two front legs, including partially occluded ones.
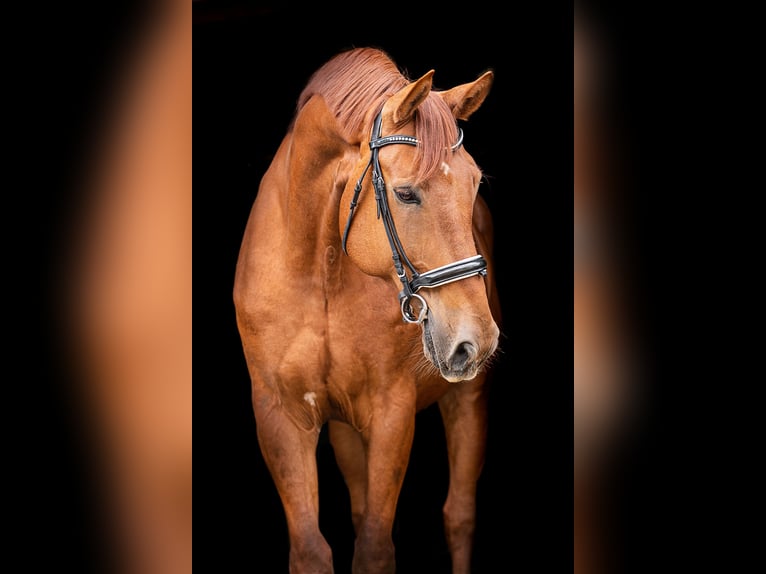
[328,421,367,534]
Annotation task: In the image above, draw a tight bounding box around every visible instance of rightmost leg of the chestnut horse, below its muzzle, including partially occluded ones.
[439,375,487,574]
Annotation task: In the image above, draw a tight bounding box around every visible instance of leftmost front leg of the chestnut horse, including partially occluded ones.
[253,394,333,574]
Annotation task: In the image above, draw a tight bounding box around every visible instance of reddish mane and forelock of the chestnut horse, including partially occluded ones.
[296,48,458,187]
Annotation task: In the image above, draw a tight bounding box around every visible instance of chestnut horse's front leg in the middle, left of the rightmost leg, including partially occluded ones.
[352,384,415,574]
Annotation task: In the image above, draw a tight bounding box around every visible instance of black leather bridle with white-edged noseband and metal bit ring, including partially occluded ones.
[343,111,487,323]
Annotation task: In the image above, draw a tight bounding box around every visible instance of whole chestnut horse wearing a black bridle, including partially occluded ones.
[234,48,500,574]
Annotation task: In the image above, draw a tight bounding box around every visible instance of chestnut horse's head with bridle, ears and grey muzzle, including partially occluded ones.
[339,70,499,382]
